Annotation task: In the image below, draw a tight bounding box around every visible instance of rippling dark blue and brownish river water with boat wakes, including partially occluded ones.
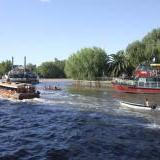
[0,81,160,160]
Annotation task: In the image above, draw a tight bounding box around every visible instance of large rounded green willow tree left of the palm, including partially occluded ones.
[65,47,107,80]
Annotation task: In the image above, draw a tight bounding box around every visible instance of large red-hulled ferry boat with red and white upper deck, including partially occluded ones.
[112,64,160,93]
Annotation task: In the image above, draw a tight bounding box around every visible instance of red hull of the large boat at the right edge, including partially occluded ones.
[112,83,160,93]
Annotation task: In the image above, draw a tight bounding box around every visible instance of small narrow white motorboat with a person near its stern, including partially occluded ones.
[119,101,160,110]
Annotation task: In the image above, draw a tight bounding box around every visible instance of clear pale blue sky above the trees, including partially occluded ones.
[0,0,160,65]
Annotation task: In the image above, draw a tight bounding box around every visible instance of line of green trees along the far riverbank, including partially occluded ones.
[0,28,160,80]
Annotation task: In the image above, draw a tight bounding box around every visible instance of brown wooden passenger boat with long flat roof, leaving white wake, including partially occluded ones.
[0,82,40,100]
